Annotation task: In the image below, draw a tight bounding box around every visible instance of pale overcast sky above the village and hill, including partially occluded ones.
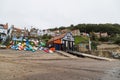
[0,0,120,29]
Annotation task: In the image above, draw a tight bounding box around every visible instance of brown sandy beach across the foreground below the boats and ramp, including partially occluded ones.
[0,49,120,80]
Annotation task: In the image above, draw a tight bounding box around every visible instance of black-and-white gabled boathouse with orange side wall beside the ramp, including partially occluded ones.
[48,32,74,51]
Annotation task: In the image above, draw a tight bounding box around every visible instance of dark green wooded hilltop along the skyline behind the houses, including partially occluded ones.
[51,23,120,35]
